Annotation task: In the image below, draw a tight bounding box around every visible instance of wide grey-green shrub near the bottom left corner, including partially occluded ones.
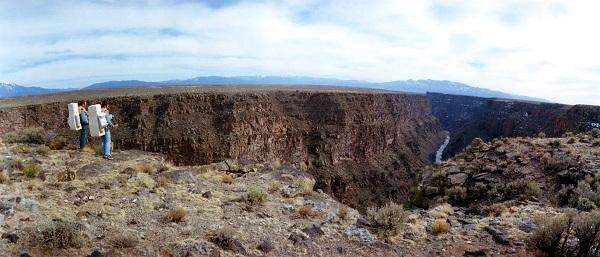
[32,220,89,250]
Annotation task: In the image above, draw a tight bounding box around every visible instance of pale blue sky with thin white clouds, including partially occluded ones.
[0,0,600,105]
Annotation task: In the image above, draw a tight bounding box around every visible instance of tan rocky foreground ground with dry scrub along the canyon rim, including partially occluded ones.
[0,129,600,256]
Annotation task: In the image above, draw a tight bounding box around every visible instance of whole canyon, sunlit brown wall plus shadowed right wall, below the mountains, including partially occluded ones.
[0,85,600,211]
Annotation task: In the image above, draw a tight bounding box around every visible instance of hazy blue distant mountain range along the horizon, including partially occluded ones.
[0,76,548,102]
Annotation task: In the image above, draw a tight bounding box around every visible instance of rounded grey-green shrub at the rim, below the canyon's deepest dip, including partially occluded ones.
[367,202,408,236]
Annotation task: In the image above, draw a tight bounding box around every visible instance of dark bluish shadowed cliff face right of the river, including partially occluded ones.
[427,93,600,158]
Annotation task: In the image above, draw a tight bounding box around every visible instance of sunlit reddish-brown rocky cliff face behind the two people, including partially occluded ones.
[0,90,443,207]
